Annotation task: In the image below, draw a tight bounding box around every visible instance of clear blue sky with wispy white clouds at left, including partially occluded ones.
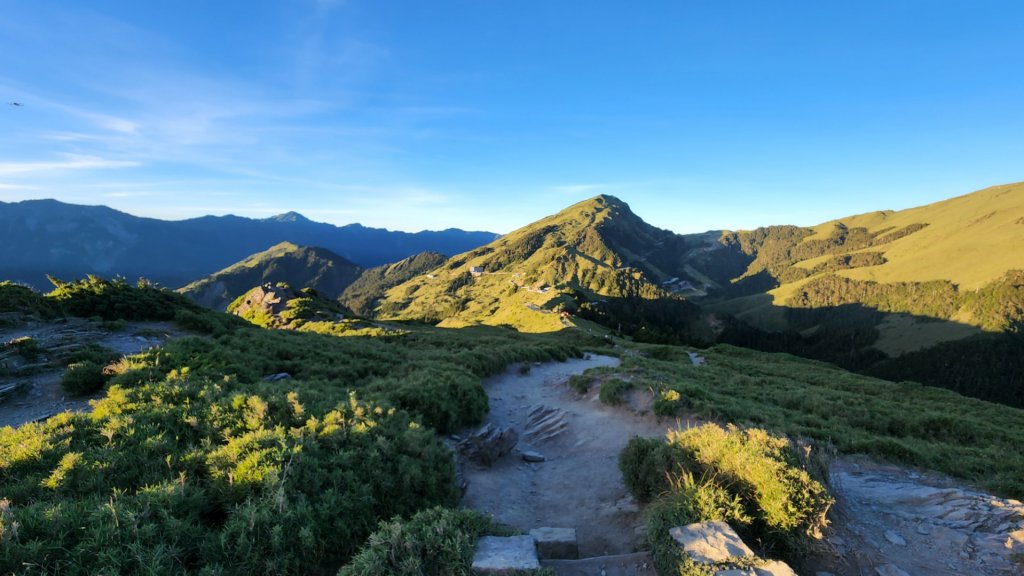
[0,0,1024,233]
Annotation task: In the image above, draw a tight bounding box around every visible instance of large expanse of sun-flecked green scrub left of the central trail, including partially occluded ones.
[0,276,579,574]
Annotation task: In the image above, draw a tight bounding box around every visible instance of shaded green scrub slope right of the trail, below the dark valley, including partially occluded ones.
[600,344,1024,498]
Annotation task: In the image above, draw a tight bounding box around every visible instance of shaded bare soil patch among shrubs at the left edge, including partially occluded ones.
[0,318,185,427]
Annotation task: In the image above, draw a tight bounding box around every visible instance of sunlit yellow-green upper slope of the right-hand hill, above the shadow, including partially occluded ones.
[714,183,1024,336]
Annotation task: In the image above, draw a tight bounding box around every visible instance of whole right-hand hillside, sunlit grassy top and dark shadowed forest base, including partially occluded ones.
[701,183,1024,406]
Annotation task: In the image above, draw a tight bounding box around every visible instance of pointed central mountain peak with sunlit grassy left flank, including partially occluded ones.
[377,196,699,332]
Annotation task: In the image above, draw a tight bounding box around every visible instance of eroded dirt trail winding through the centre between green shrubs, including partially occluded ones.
[462,356,692,558]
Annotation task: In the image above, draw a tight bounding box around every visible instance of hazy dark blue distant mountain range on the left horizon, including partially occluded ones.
[0,200,497,289]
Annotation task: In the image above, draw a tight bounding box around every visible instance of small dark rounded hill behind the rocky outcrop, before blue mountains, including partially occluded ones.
[179,242,362,311]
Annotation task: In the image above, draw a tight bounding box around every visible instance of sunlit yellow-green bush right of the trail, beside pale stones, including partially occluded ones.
[620,424,833,574]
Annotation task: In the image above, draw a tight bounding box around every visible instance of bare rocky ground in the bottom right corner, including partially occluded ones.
[809,457,1024,576]
